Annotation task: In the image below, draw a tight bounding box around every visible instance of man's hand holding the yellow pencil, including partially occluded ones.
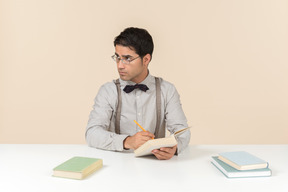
[124,131,155,150]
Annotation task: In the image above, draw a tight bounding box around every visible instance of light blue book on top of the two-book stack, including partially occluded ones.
[218,151,268,170]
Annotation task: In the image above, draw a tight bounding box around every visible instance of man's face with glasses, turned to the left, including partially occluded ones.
[115,45,150,83]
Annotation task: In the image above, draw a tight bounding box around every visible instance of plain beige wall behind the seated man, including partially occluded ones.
[0,0,288,144]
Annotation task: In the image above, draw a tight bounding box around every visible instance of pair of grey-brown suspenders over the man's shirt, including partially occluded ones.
[115,77,165,138]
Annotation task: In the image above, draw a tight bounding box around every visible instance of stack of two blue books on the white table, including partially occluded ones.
[211,151,272,178]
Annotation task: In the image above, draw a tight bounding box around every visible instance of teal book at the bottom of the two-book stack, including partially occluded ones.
[211,156,272,178]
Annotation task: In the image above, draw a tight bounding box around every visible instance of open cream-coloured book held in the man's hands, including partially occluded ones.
[134,127,191,157]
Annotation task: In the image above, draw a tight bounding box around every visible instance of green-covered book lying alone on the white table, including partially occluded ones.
[53,157,103,179]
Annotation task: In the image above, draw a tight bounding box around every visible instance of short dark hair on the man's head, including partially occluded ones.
[114,27,154,59]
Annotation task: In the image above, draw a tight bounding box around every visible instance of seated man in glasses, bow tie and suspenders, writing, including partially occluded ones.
[86,27,190,159]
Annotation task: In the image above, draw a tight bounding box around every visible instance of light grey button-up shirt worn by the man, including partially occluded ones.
[86,74,190,154]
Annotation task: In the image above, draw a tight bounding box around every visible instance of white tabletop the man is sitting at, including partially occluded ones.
[0,144,288,192]
